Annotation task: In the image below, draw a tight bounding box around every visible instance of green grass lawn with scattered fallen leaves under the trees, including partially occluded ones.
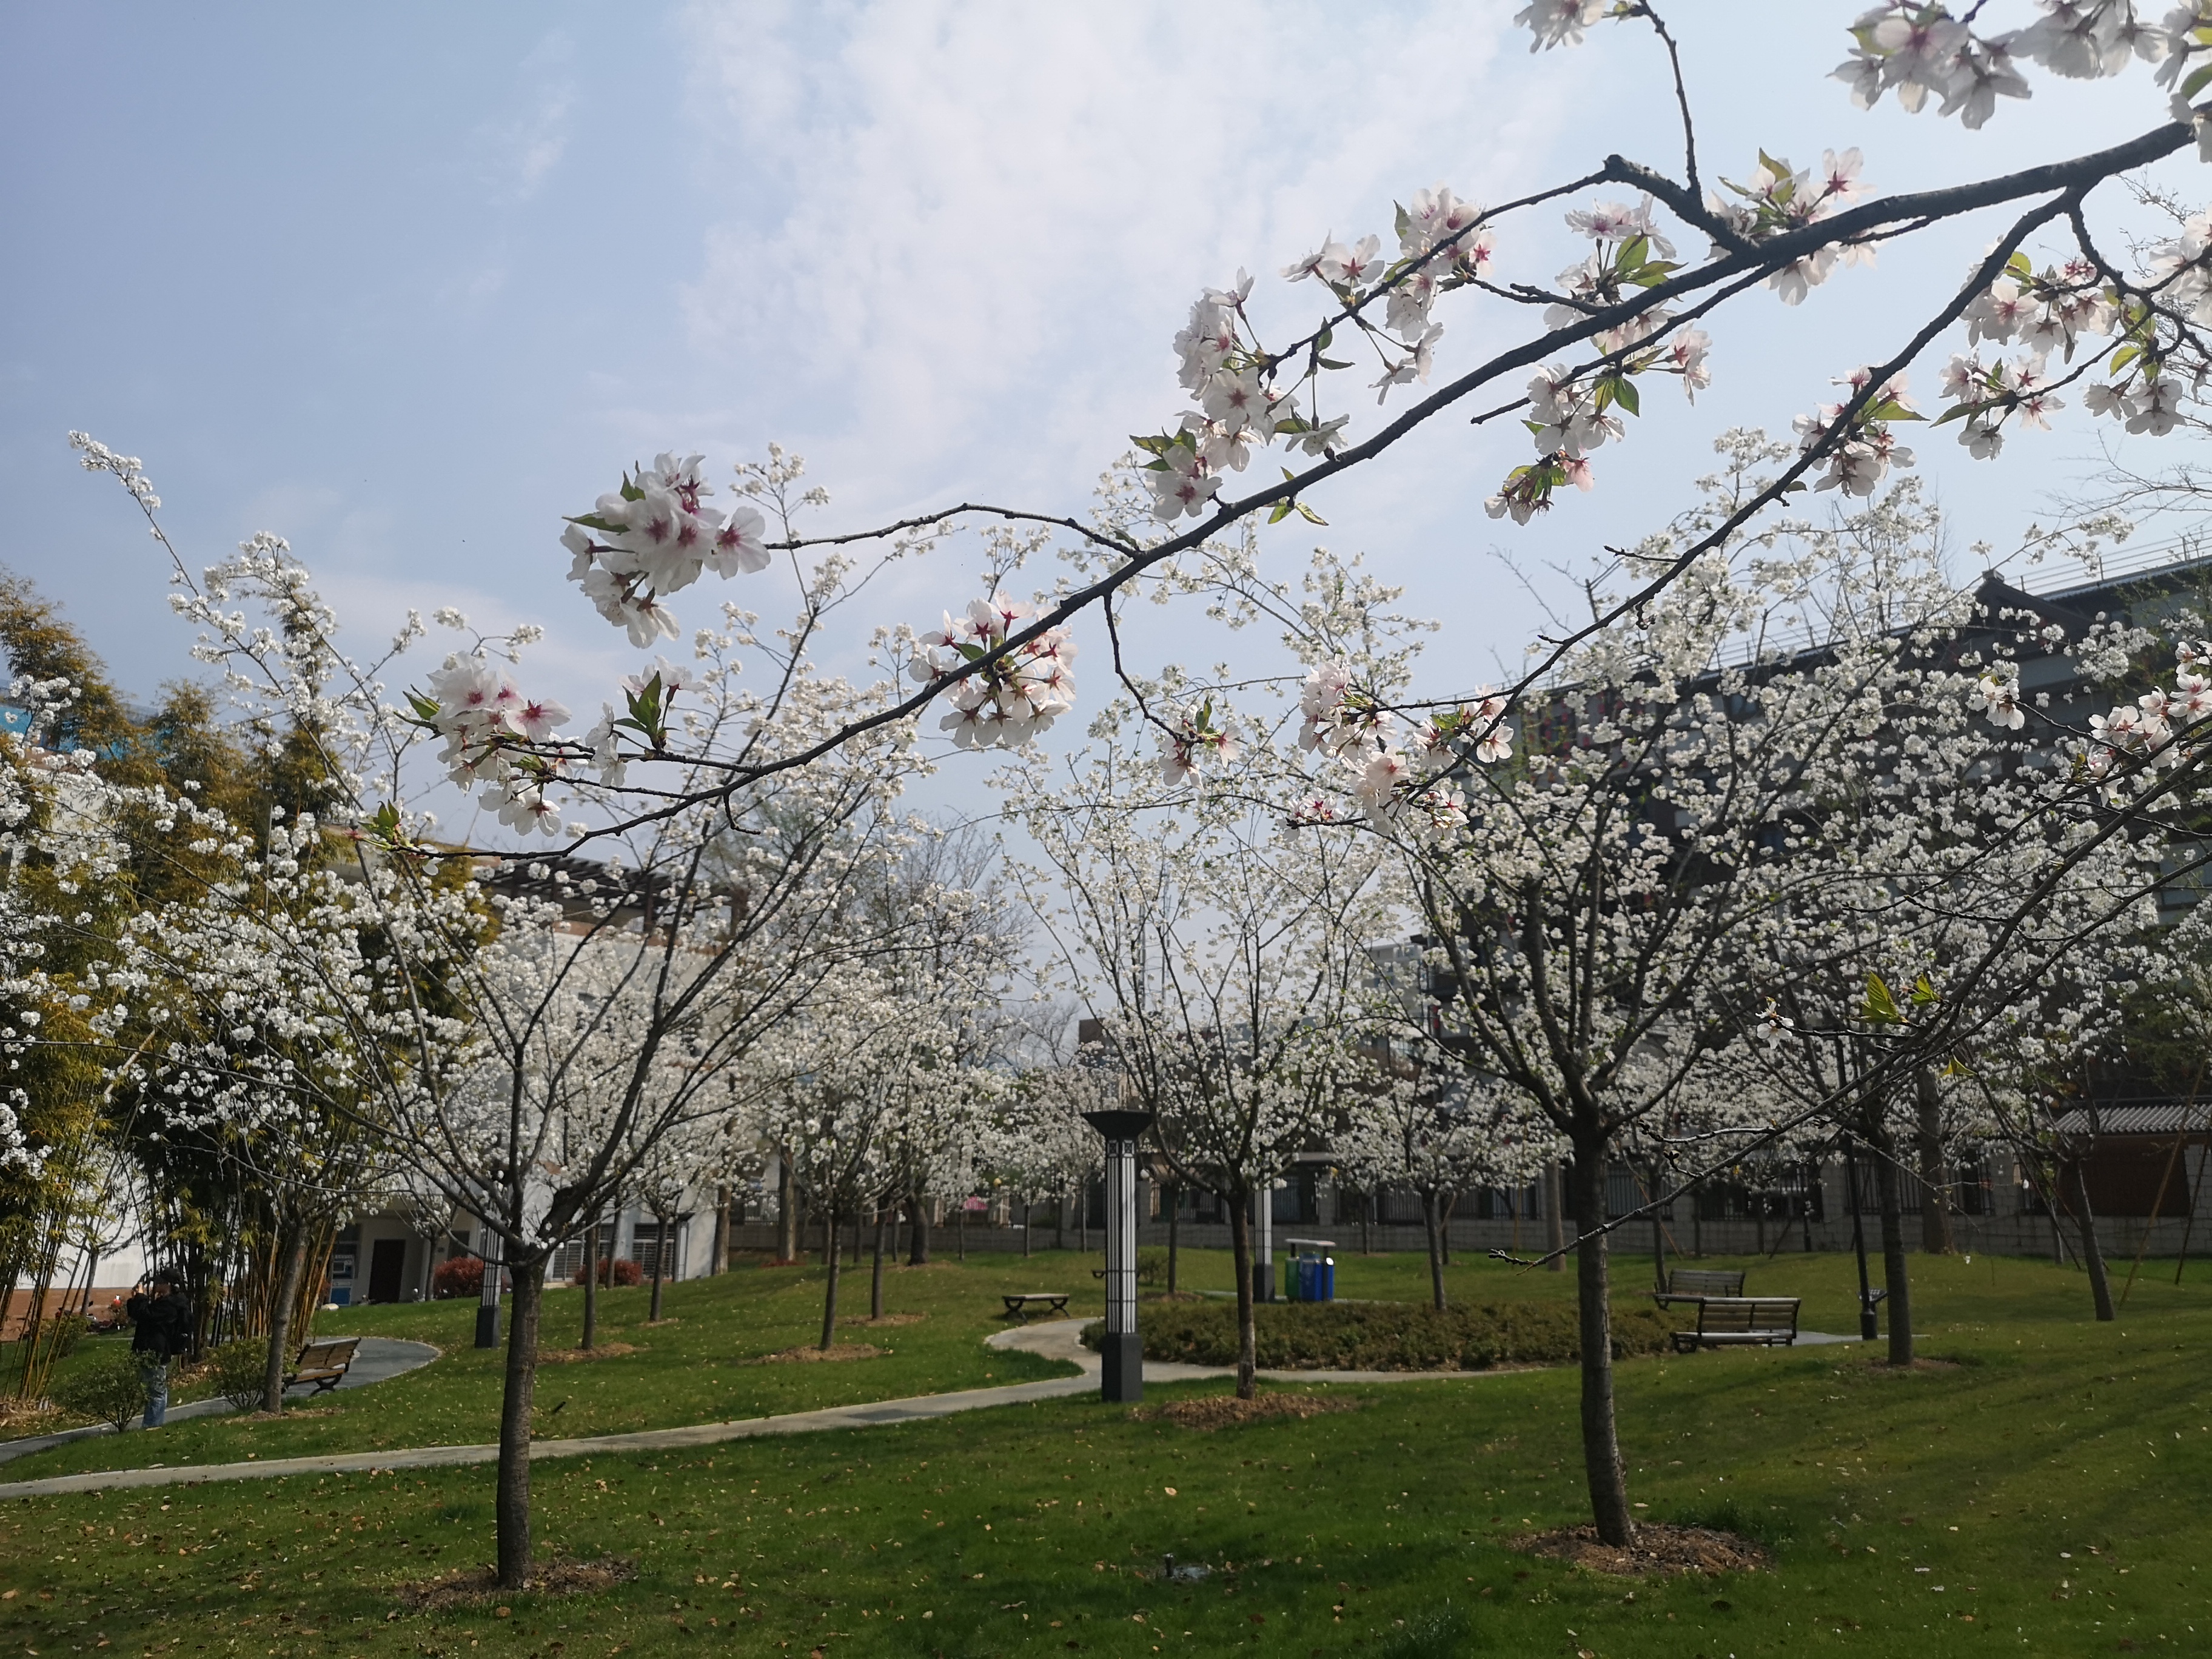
[0,1254,2212,1659]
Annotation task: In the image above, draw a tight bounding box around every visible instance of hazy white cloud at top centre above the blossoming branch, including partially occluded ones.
[686,0,1566,520]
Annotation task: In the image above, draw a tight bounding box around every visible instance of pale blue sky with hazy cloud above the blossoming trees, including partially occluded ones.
[0,0,2201,845]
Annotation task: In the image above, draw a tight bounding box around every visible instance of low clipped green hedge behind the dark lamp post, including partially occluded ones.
[1084,1298,1675,1372]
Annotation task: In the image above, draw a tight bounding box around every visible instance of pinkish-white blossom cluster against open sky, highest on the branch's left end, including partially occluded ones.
[560,455,768,646]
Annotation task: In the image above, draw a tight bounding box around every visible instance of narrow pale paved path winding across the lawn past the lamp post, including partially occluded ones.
[0,1318,1847,1500]
